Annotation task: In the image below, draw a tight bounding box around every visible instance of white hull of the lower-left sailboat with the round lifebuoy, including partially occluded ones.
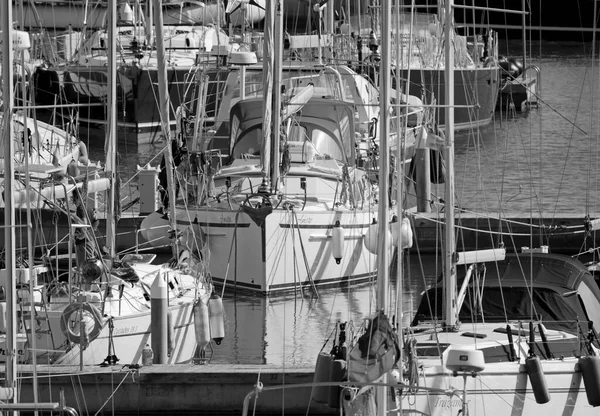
[0,263,212,365]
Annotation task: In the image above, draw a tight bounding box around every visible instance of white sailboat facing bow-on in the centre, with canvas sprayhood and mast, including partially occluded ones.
[141,3,428,295]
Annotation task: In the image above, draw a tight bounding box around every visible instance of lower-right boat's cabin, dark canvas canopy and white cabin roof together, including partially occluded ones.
[408,253,600,362]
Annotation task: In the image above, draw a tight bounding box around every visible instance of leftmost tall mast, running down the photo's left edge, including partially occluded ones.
[0,1,17,402]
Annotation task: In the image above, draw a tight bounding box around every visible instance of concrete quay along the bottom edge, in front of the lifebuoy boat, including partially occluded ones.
[18,364,332,415]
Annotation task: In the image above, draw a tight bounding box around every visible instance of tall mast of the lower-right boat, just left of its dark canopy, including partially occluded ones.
[444,0,458,330]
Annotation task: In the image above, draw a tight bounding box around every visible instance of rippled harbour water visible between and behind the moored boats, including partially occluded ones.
[79,43,600,366]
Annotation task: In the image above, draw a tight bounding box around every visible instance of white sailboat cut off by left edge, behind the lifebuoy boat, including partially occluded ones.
[0,25,108,254]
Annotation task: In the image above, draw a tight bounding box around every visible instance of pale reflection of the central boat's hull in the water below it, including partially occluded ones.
[207,255,435,368]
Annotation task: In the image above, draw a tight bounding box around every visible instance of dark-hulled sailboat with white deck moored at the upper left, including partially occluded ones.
[35,1,229,144]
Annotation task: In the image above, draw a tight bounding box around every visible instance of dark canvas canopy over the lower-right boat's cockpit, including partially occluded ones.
[412,254,600,331]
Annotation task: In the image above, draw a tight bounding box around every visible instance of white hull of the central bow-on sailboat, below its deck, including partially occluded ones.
[178,208,384,294]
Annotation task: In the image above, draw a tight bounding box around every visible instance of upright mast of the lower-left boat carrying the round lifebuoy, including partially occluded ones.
[104,1,117,259]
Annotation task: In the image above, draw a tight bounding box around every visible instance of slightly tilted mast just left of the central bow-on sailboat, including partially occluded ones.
[153,0,177,257]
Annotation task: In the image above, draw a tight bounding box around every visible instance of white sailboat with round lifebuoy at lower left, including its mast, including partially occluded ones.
[0,3,212,367]
